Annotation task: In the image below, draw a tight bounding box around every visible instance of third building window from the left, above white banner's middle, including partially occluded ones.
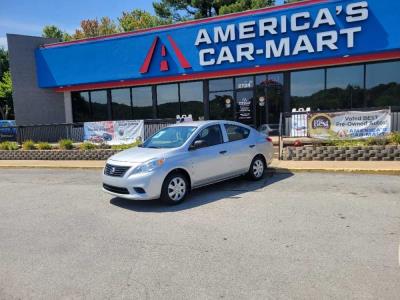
[111,89,132,120]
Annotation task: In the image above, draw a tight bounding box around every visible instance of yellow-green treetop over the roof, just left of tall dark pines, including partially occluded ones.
[118,9,171,32]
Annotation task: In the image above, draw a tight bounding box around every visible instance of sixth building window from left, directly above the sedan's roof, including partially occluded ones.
[180,81,204,120]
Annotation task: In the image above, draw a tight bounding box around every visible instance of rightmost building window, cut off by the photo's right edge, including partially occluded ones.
[366,61,400,107]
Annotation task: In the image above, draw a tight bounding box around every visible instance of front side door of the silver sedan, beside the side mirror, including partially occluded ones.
[189,124,230,186]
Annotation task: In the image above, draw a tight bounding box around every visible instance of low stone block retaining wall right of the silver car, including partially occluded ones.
[283,146,400,161]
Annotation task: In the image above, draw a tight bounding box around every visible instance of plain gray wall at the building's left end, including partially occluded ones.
[7,34,65,125]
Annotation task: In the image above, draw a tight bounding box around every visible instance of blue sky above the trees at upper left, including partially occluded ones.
[0,0,283,49]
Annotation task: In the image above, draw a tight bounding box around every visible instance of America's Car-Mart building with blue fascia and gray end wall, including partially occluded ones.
[8,0,400,126]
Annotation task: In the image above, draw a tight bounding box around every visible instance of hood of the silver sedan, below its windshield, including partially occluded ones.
[109,147,172,163]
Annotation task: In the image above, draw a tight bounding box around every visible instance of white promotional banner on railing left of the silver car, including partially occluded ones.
[83,120,144,145]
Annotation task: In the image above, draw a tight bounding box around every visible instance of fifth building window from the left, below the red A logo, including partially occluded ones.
[157,83,180,119]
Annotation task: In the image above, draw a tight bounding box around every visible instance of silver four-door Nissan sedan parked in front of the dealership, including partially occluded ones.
[103,121,273,204]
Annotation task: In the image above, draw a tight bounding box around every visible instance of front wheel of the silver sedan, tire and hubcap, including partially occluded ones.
[160,172,190,205]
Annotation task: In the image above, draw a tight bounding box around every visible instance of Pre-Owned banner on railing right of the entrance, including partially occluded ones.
[308,110,391,140]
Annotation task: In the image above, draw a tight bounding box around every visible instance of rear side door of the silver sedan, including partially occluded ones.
[224,124,255,175]
